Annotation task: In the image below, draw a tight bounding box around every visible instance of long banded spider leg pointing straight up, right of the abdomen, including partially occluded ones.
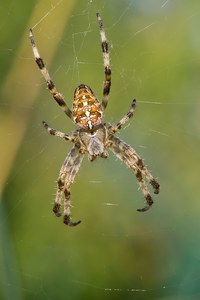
[97,13,111,110]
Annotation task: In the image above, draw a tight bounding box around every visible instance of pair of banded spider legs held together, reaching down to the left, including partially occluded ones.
[53,146,83,226]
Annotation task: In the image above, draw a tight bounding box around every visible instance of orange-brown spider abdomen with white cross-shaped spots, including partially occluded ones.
[72,84,103,129]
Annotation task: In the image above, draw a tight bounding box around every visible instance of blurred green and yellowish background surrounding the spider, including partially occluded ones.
[0,0,200,300]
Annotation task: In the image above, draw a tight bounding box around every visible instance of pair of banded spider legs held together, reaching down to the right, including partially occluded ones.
[110,136,159,212]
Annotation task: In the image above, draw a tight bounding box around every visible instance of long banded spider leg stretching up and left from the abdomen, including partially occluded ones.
[29,29,72,119]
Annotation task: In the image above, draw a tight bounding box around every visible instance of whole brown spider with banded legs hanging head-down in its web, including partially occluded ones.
[30,13,159,226]
